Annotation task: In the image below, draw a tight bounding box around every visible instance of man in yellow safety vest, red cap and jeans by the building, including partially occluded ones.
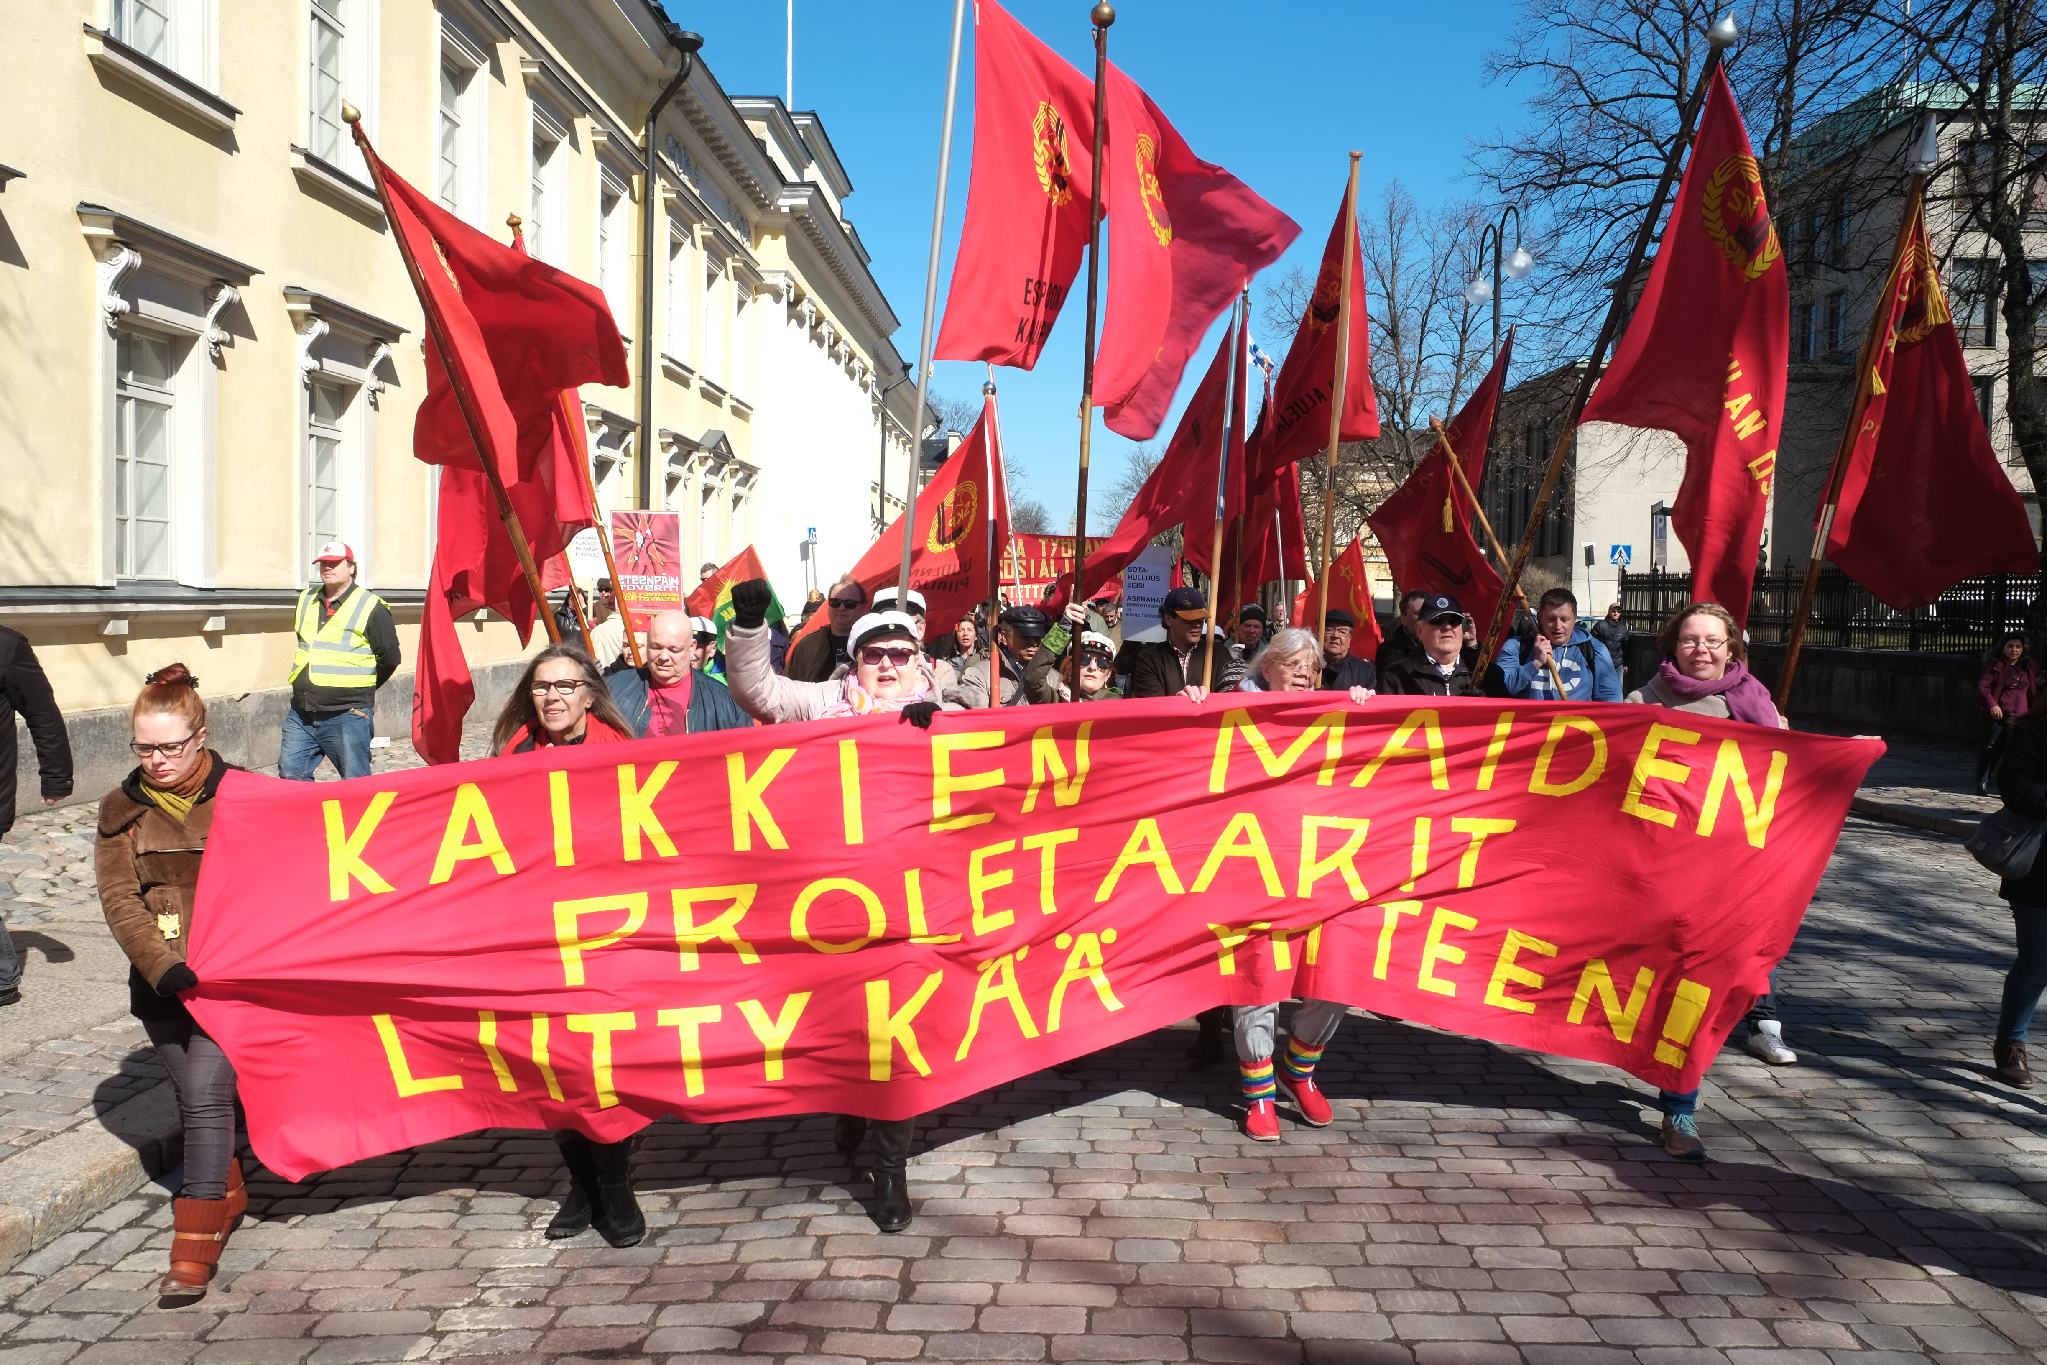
[276,540,399,782]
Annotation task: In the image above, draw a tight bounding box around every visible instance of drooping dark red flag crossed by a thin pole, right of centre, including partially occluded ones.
[1365,332,1515,638]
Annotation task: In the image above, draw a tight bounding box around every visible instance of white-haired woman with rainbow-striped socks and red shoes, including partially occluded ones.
[1234,626,1374,1142]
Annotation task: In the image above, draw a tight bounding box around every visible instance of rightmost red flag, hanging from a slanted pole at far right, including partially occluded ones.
[1826,203,2039,612]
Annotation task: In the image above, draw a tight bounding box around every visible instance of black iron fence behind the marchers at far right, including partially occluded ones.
[1621,567,2041,655]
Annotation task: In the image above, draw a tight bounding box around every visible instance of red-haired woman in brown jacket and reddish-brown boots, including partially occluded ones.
[94,663,250,1302]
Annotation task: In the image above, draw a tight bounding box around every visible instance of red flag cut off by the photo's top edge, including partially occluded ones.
[933,0,1095,370]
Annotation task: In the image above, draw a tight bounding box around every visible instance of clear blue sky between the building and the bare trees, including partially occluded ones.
[669,0,1521,532]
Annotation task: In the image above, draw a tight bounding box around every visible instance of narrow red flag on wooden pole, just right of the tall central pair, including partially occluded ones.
[1251,185,1380,481]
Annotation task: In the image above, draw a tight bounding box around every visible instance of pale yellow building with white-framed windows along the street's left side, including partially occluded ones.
[0,0,913,794]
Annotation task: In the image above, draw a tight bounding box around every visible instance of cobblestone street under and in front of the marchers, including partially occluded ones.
[0,785,2047,1365]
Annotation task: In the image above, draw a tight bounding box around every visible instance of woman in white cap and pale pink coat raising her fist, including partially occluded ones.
[725,579,960,1232]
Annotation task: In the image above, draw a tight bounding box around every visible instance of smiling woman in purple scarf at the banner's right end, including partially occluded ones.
[1627,602,1797,1162]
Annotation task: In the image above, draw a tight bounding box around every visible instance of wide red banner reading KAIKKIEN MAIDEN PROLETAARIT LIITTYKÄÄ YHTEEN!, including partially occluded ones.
[190,694,1883,1179]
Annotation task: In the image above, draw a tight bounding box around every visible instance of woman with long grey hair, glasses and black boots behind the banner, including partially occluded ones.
[478,645,647,1246]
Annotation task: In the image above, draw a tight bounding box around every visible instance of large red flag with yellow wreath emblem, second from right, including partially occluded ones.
[1578,72,1791,622]
